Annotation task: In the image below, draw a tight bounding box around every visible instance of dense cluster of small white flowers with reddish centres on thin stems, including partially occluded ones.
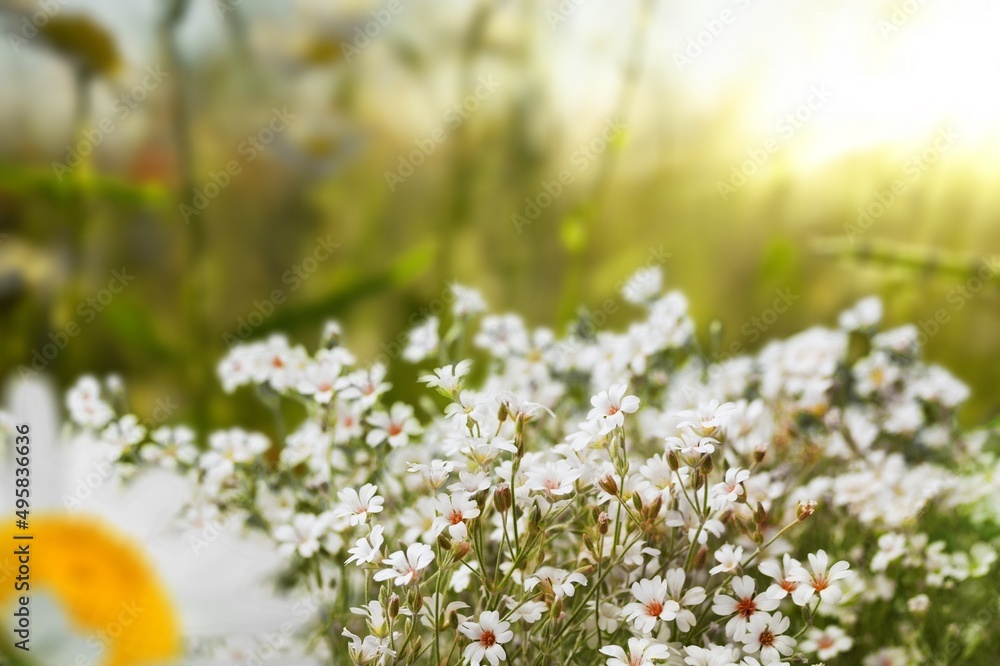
[62,269,1000,666]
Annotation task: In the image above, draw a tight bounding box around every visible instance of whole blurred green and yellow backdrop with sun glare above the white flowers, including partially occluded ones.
[0,0,1000,426]
